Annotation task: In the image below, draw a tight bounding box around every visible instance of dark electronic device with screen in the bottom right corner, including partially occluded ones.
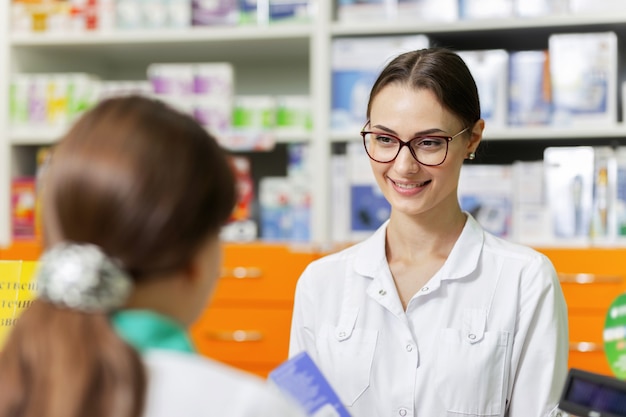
[559,368,626,417]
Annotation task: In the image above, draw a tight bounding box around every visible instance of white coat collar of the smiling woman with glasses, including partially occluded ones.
[354,213,485,280]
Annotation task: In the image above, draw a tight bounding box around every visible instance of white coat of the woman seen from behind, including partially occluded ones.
[143,350,305,417]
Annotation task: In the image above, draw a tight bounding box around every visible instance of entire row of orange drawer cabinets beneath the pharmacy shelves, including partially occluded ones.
[0,237,626,377]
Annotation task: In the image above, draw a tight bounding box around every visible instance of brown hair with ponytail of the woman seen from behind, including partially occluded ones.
[0,97,236,417]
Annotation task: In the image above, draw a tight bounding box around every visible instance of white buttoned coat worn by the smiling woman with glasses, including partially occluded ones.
[289,214,568,417]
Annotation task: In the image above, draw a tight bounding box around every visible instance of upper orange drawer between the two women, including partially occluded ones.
[213,243,317,307]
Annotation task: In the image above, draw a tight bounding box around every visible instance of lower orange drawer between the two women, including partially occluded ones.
[190,306,291,368]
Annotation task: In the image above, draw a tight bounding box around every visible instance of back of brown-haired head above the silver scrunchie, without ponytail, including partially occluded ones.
[43,97,235,280]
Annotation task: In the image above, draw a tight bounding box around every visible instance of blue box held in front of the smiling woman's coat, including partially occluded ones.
[268,352,350,417]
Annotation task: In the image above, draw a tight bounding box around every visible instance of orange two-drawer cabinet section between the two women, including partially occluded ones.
[186,240,318,377]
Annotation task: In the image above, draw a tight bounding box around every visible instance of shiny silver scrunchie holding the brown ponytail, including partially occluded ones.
[36,243,133,313]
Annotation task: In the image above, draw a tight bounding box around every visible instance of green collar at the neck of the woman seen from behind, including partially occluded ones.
[111,310,195,353]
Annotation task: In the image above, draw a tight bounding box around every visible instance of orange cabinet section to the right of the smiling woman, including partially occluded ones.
[538,248,626,375]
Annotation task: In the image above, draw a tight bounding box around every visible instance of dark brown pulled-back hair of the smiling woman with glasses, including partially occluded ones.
[366,47,480,126]
